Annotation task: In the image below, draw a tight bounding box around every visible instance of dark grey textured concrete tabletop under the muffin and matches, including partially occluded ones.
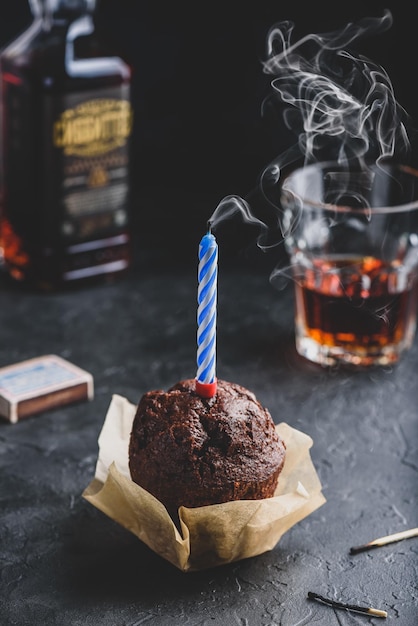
[0,241,418,626]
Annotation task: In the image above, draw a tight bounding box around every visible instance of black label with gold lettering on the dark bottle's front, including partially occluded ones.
[45,87,132,245]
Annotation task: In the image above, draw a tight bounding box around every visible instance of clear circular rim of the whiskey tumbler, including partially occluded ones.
[280,161,418,216]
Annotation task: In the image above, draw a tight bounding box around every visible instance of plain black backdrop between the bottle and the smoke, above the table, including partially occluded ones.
[0,0,418,255]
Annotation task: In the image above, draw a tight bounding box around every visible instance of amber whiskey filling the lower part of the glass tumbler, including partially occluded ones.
[295,257,418,365]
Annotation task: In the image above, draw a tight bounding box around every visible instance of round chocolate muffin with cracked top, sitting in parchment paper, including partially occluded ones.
[129,379,285,515]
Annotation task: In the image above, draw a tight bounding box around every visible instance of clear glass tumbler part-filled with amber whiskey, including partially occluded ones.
[280,162,418,366]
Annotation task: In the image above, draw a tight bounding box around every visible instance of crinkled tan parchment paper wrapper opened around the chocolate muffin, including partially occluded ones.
[83,395,325,572]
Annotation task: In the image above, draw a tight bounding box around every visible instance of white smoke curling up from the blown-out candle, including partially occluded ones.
[209,10,410,258]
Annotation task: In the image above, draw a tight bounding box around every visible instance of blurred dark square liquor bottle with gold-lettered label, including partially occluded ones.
[0,0,133,289]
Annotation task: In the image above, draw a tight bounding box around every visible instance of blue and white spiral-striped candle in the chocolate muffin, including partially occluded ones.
[196,227,218,398]
